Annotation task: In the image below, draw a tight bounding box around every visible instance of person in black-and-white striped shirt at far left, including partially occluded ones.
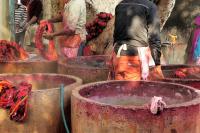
[15,0,27,46]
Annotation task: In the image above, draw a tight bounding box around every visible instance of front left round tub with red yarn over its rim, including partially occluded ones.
[0,73,82,133]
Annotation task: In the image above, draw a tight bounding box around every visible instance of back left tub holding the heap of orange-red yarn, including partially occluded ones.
[0,54,57,73]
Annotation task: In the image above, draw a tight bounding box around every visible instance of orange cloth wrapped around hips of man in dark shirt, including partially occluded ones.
[114,56,141,80]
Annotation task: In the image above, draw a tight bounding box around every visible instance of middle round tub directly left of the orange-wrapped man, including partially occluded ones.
[58,55,109,83]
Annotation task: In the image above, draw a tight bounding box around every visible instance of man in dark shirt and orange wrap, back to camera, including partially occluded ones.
[114,0,163,80]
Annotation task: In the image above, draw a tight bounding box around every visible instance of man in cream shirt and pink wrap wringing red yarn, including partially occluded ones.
[44,0,86,57]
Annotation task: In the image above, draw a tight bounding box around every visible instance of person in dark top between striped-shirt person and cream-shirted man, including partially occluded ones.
[24,0,42,46]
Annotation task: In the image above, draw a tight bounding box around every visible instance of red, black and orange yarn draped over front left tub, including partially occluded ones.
[0,80,32,122]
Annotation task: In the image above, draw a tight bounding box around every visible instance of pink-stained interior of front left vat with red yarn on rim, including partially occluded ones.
[0,74,75,90]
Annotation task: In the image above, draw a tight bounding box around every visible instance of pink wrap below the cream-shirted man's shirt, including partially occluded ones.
[62,47,78,58]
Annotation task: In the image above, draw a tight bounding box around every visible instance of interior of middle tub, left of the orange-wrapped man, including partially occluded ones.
[61,56,108,68]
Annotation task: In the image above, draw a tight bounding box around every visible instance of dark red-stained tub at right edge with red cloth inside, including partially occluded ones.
[162,65,200,90]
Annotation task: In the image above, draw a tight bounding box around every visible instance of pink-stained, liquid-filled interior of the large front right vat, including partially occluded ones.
[79,81,198,106]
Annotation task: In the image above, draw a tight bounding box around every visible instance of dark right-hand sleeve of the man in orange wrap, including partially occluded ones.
[147,5,161,66]
